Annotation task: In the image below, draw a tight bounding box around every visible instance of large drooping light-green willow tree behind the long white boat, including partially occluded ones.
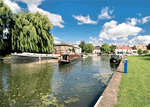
[11,11,54,53]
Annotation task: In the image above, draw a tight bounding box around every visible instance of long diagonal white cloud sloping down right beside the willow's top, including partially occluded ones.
[28,4,64,28]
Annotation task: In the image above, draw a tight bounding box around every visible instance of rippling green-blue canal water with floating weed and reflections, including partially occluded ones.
[0,56,118,107]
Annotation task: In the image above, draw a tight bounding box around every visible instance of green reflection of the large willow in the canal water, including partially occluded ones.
[0,60,53,106]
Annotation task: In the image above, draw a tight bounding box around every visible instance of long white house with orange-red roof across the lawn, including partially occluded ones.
[115,45,132,54]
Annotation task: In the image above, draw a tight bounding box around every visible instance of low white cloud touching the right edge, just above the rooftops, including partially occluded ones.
[129,35,150,45]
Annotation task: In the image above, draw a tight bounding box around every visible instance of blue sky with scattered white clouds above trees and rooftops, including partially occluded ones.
[3,0,150,46]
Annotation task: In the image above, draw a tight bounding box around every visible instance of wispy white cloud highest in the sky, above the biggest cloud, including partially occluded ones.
[98,7,115,19]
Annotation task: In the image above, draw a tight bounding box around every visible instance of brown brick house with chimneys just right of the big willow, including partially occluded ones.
[54,41,74,54]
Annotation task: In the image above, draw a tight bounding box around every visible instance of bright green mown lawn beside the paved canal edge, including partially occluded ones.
[115,56,150,107]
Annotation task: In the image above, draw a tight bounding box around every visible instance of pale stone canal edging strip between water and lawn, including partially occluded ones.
[94,55,124,107]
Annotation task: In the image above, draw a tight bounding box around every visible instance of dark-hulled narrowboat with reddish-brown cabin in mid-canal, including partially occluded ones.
[59,54,81,66]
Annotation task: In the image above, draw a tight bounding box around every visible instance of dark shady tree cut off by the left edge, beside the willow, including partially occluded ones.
[0,0,12,56]
